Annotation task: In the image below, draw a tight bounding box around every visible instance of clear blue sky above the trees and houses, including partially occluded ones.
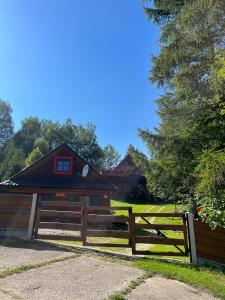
[0,0,159,155]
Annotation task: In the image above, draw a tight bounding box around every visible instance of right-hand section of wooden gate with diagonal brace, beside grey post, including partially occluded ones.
[132,213,189,256]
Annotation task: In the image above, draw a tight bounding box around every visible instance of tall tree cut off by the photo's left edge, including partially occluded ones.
[0,100,13,148]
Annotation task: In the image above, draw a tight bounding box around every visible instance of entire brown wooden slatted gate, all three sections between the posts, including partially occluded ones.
[34,201,189,256]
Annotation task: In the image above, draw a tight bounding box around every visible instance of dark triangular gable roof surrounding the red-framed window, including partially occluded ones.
[0,143,117,192]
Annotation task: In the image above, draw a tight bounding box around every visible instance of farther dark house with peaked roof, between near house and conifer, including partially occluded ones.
[103,154,150,199]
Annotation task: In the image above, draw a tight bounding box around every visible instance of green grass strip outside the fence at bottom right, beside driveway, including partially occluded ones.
[132,259,225,299]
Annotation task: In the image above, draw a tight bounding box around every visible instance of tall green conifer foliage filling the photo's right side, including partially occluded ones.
[139,0,225,225]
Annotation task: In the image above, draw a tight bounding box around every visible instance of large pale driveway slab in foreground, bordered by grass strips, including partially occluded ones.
[0,255,143,300]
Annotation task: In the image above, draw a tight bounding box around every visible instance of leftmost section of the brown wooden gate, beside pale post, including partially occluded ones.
[34,201,85,241]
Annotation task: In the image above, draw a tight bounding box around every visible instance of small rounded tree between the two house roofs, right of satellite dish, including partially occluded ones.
[101,145,120,171]
